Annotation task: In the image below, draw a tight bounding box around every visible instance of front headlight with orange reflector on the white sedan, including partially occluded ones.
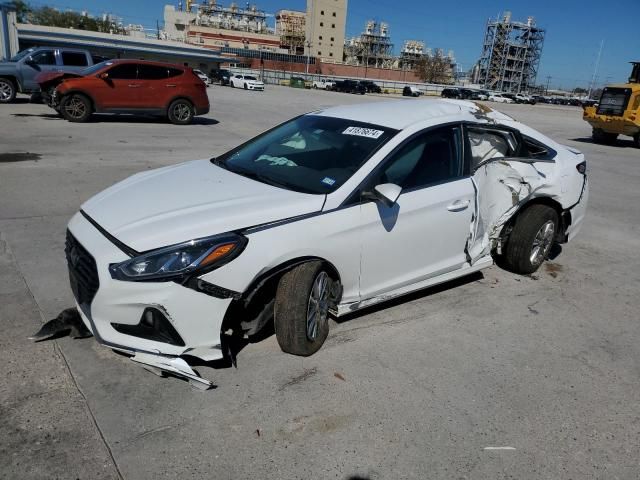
[109,233,247,282]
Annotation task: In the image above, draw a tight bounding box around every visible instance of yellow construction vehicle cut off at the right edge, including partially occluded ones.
[582,62,640,148]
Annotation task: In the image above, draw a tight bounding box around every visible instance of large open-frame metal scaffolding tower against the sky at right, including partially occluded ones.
[479,12,545,93]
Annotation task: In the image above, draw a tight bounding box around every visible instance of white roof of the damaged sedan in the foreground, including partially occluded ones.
[314,99,478,130]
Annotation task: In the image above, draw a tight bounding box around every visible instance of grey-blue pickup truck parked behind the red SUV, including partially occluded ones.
[0,47,100,103]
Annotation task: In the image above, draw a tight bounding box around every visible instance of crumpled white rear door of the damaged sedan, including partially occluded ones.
[465,120,556,265]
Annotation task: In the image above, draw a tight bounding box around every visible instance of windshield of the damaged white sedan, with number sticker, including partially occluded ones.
[212,115,397,194]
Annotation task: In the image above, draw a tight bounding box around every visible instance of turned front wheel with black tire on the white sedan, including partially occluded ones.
[273,262,332,357]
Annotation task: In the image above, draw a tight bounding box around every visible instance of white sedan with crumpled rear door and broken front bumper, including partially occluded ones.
[66,100,588,385]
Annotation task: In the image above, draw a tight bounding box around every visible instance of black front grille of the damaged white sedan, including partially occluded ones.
[64,230,100,316]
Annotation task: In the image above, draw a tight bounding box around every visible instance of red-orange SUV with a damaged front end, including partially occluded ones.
[46,60,209,125]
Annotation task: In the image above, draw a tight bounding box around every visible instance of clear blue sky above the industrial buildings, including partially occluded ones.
[27,0,640,88]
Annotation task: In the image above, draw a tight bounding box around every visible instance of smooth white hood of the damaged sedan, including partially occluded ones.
[82,160,325,252]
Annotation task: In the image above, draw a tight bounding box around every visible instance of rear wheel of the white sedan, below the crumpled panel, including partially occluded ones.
[502,205,558,275]
